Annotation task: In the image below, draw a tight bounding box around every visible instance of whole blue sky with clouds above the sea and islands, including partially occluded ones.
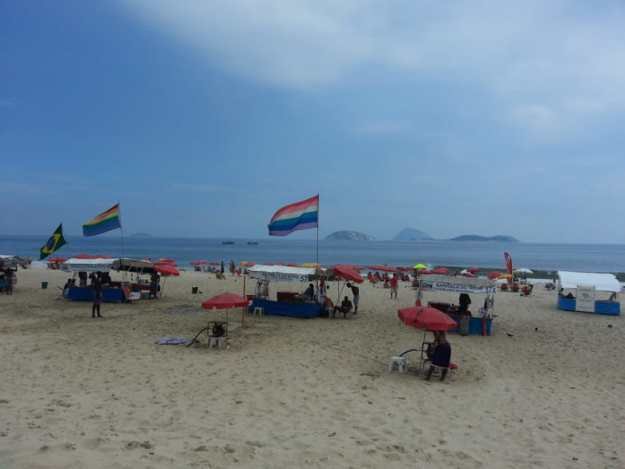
[0,0,625,243]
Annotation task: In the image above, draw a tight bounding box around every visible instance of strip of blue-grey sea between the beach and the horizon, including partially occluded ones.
[0,236,625,272]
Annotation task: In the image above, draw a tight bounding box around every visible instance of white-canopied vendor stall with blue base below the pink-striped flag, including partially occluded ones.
[247,264,323,318]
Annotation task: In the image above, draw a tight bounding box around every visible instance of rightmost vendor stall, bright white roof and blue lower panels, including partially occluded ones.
[556,271,622,316]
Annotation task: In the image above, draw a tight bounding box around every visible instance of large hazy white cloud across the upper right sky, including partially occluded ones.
[120,0,625,134]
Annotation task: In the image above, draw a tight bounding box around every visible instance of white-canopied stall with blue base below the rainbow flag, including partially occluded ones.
[63,257,127,303]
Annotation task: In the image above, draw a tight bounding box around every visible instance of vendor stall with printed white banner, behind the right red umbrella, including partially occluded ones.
[417,275,497,336]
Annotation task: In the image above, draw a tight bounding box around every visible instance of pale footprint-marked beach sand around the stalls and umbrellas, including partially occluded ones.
[0,269,625,469]
